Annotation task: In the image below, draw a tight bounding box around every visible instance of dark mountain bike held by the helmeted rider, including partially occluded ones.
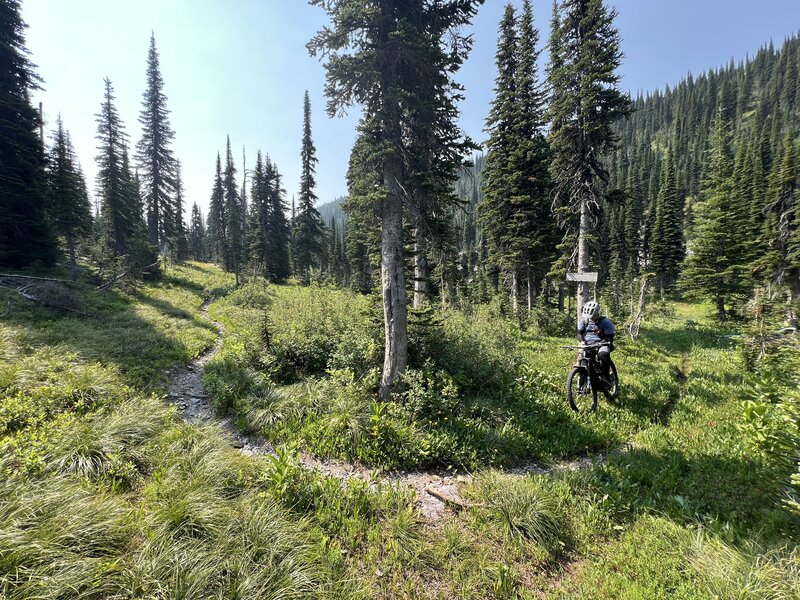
[564,342,619,413]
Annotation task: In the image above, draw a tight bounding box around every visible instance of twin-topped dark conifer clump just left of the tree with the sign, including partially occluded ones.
[479,0,557,311]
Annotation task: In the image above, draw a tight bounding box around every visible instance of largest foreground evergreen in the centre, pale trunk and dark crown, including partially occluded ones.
[309,0,482,400]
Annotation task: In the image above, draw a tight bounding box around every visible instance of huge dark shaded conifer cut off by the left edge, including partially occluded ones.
[0,0,56,267]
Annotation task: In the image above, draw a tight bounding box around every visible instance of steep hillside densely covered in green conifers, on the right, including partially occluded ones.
[605,36,800,316]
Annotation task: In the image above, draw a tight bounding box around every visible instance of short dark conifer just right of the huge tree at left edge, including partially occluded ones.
[47,115,92,281]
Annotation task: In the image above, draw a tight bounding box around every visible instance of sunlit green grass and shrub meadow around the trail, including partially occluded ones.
[0,263,800,599]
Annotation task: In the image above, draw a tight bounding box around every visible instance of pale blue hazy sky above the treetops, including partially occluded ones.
[22,0,800,218]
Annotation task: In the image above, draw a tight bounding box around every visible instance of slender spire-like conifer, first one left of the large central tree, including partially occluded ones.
[293,92,325,284]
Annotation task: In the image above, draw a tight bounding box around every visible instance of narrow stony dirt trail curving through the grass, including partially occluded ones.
[169,297,620,522]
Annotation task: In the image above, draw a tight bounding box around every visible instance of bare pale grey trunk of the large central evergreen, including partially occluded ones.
[380,153,408,401]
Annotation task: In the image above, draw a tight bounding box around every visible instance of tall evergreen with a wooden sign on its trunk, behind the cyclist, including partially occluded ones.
[549,0,630,318]
